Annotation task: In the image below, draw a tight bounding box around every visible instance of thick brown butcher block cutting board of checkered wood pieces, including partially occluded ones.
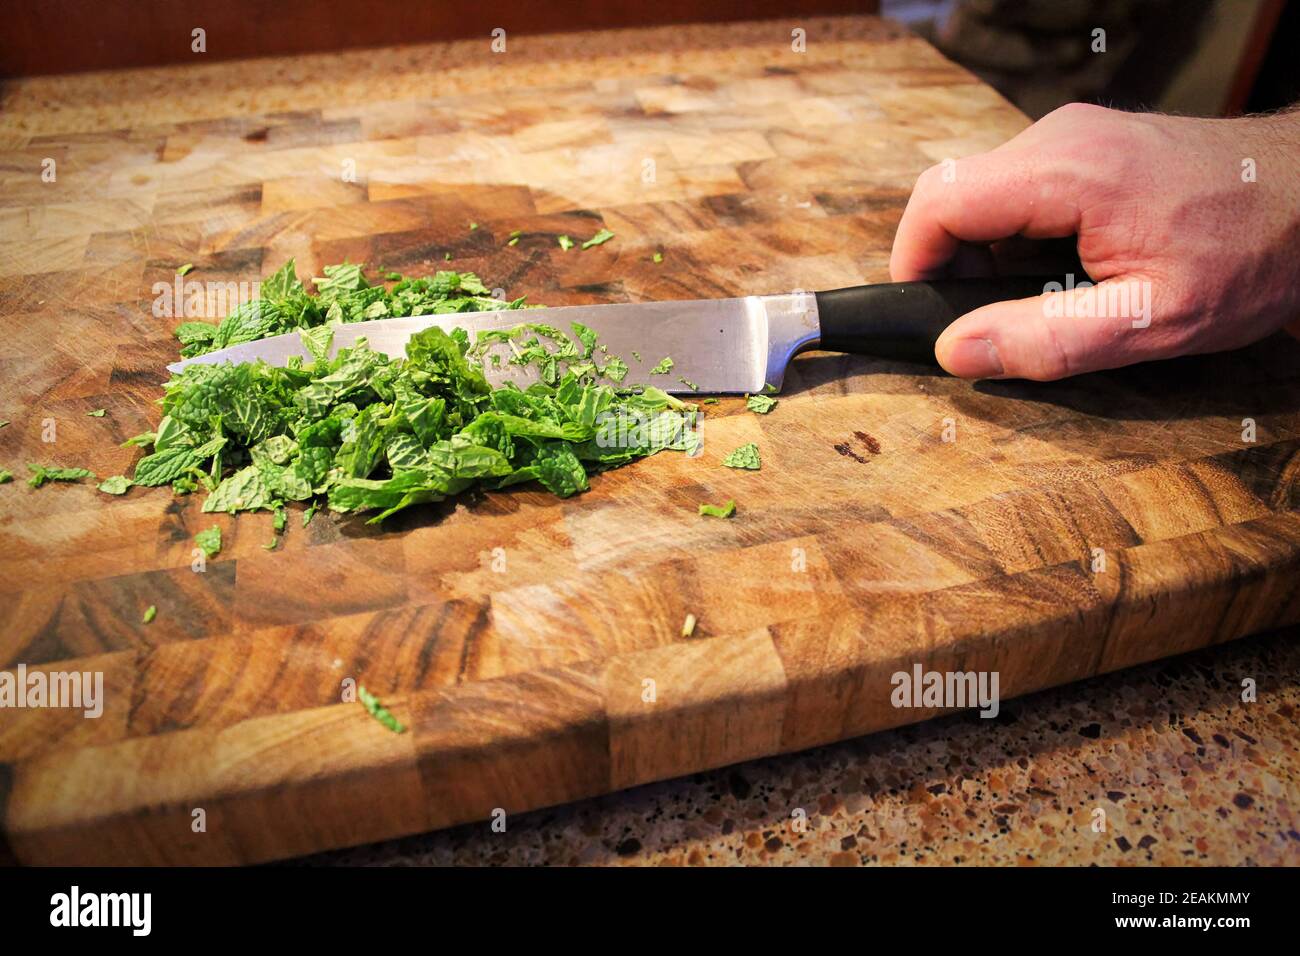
[0,18,1300,864]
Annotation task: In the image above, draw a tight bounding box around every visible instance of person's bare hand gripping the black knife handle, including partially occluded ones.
[889,103,1300,381]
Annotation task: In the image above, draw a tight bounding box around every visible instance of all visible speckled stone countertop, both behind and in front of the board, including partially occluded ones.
[0,20,1300,866]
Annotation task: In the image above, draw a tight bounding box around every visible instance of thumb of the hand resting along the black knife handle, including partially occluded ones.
[935,278,1165,381]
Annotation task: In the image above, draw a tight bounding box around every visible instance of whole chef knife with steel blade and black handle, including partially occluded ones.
[168,276,1063,393]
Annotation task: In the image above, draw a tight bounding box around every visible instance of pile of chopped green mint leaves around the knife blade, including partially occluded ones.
[124,260,698,528]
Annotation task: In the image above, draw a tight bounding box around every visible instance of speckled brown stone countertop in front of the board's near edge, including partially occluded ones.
[297,628,1300,866]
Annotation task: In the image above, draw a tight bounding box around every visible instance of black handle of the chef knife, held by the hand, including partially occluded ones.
[816,276,1071,364]
